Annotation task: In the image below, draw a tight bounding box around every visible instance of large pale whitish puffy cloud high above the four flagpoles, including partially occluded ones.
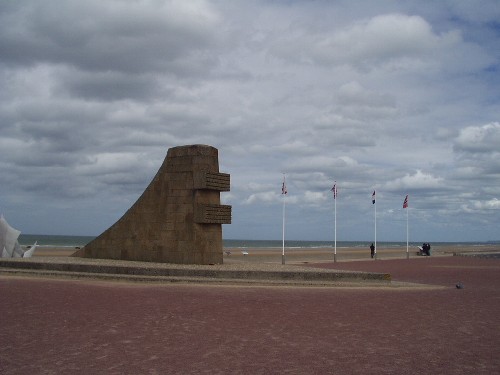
[273,13,470,71]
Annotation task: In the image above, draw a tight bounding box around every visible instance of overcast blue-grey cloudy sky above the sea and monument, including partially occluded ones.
[0,0,500,242]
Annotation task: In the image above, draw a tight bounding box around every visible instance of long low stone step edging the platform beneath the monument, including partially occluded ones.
[0,258,391,285]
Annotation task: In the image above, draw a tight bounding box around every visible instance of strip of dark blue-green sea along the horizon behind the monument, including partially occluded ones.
[18,233,500,250]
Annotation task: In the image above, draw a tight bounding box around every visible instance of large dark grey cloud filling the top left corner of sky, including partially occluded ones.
[0,1,221,76]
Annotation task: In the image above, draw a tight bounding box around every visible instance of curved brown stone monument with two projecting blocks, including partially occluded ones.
[73,145,231,264]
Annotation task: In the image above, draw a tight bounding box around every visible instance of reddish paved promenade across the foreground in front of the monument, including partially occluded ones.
[0,257,500,375]
